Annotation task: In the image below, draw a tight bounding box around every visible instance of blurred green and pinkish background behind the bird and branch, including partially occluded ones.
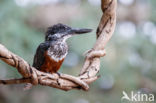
[0,0,156,103]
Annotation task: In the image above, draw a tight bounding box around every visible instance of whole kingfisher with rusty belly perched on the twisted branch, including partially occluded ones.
[33,23,92,73]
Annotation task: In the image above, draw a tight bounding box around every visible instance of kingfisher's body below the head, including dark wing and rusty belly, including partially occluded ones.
[33,41,68,73]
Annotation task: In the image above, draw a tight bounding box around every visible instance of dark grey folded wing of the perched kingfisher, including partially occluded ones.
[33,42,49,70]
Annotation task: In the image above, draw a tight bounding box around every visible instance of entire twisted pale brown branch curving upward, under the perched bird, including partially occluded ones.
[0,0,117,91]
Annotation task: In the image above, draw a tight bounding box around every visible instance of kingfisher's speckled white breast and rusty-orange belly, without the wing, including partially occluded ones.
[40,42,68,73]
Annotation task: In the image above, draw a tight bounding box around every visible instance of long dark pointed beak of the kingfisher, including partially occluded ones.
[68,28,92,35]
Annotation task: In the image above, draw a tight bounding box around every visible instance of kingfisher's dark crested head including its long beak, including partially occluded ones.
[45,23,92,41]
